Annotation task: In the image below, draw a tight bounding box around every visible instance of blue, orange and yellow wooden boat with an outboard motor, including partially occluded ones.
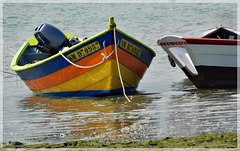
[11,17,155,96]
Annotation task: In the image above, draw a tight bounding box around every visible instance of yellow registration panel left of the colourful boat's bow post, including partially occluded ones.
[67,41,101,62]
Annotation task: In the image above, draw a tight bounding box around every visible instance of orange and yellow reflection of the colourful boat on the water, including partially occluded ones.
[22,95,148,139]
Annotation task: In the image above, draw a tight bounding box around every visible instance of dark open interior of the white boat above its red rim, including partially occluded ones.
[202,27,240,39]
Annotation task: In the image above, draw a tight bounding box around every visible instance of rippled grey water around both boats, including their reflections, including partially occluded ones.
[3,3,238,144]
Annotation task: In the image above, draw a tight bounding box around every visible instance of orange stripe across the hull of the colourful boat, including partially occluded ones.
[24,45,148,91]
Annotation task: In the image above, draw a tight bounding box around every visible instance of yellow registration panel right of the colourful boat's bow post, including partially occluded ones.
[120,39,142,57]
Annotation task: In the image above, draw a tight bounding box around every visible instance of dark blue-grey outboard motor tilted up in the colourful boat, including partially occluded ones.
[34,24,80,55]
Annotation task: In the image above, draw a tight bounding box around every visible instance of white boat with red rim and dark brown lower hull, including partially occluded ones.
[157,26,240,88]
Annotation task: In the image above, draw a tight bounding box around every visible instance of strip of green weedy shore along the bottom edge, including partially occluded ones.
[3,133,237,148]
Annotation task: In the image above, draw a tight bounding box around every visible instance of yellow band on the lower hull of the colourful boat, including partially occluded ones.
[31,60,141,94]
